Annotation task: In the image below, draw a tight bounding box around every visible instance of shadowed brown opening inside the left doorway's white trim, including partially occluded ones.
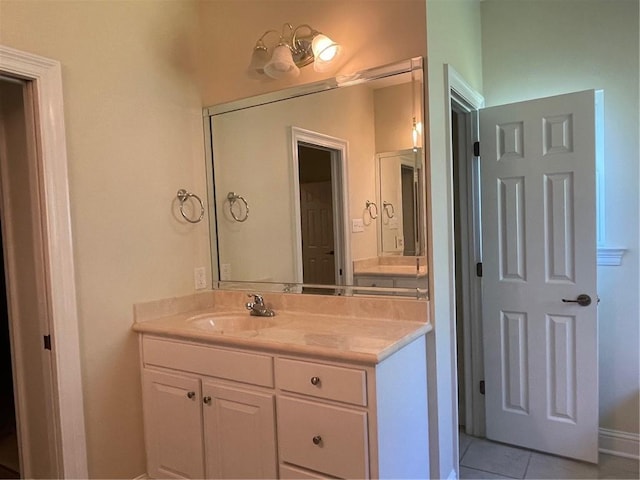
[0,76,59,478]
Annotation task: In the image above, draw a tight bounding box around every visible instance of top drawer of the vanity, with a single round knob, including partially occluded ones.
[276,358,367,406]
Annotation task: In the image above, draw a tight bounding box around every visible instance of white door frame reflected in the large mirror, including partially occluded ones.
[291,127,353,285]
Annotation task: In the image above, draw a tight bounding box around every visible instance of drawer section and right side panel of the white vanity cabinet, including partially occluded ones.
[276,337,429,478]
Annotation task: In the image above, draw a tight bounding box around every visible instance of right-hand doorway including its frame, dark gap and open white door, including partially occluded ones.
[448,65,601,462]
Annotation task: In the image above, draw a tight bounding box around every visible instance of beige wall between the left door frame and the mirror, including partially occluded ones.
[0,0,209,478]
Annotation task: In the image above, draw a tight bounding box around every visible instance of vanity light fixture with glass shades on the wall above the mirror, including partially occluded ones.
[249,23,342,78]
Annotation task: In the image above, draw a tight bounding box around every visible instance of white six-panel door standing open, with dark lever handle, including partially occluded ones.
[480,91,598,462]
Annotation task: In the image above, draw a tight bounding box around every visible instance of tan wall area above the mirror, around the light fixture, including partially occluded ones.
[201,0,426,105]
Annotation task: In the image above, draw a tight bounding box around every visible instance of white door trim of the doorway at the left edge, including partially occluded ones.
[0,45,88,478]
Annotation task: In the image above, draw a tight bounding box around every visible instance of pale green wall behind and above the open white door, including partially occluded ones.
[482,0,640,433]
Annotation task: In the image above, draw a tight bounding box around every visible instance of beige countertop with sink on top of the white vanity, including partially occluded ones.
[133,308,432,365]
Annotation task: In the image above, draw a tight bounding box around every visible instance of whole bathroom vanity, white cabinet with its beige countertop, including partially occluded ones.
[133,290,430,478]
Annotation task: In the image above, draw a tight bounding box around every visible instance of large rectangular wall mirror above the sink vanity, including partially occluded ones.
[205,58,428,299]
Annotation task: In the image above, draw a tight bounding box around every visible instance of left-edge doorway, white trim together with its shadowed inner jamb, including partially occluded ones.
[0,45,88,478]
